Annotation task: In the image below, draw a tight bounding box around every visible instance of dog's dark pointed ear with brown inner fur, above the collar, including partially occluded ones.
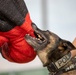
[58,40,75,57]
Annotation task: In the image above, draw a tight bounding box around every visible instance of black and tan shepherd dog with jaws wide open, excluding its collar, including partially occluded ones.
[25,24,76,75]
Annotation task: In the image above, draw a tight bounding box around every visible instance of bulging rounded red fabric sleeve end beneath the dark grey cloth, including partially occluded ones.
[0,19,36,63]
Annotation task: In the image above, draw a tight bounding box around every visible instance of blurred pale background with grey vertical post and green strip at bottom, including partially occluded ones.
[0,0,76,75]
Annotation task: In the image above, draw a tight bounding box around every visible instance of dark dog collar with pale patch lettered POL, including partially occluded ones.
[47,53,76,75]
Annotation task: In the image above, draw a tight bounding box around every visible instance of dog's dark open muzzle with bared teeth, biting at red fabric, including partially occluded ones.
[25,25,48,50]
